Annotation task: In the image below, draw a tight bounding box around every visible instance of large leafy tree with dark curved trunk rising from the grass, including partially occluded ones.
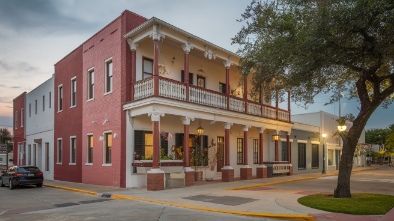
[232,0,394,198]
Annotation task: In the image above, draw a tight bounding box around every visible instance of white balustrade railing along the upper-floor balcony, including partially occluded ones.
[134,77,290,122]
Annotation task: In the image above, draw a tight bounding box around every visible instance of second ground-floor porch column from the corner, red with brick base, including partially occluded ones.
[181,117,194,186]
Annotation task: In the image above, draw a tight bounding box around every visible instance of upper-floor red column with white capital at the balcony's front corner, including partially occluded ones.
[150,25,164,96]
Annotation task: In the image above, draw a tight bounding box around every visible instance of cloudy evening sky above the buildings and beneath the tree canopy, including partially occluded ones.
[0,0,394,129]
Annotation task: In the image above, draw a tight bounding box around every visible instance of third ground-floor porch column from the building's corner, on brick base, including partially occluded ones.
[222,123,234,182]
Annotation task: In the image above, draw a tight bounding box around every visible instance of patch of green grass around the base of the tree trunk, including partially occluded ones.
[298,193,394,215]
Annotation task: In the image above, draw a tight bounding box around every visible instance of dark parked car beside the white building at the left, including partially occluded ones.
[0,166,44,190]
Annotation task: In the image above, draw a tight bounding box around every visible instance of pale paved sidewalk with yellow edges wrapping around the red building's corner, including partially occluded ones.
[44,166,394,221]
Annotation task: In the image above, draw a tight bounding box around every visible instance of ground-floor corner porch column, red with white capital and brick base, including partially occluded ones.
[147,111,164,190]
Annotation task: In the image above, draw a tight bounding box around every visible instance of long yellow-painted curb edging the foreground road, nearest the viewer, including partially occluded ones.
[110,194,315,221]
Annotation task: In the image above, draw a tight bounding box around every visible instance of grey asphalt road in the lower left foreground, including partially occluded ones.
[0,187,272,221]
